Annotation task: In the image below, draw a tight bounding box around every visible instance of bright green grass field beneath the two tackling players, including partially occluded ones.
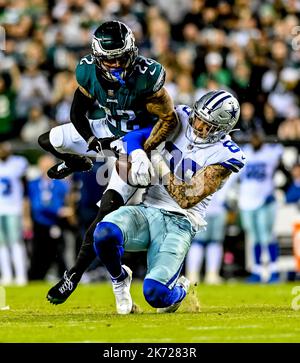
[0,282,300,343]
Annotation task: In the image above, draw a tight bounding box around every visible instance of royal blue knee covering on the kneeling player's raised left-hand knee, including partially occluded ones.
[94,222,124,256]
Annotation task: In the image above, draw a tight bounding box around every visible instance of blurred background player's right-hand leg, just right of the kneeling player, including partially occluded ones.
[204,212,226,285]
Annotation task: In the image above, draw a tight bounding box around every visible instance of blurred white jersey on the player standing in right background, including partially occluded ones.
[239,144,283,210]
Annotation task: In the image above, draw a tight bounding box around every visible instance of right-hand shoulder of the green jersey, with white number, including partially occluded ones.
[132,56,166,93]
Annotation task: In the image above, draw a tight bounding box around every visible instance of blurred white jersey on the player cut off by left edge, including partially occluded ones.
[0,156,27,215]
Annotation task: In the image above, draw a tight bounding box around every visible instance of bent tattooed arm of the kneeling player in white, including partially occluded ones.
[151,156,231,209]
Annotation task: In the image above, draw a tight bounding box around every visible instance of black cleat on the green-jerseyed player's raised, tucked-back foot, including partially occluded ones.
[47,155,93,179]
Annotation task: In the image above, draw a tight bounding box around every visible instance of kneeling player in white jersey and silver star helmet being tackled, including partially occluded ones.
[94,90,245,314]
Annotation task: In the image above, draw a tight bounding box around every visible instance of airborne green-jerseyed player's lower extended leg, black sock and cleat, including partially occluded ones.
[47,167,136,304]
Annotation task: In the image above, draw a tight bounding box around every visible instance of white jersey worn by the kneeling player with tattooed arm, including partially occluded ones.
[144,105,245,230]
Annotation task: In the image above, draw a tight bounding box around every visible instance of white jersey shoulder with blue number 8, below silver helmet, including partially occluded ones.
[216,135,247,173]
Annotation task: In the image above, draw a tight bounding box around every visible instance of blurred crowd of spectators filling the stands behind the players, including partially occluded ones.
[0,0,300,286]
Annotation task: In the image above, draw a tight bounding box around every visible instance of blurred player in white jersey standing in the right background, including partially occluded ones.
[238,131,283,283]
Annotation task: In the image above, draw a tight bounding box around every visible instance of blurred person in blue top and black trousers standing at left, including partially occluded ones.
[28,155,74,280]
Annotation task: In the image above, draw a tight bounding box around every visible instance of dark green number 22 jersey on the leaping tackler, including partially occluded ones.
[76,54,165,137]
